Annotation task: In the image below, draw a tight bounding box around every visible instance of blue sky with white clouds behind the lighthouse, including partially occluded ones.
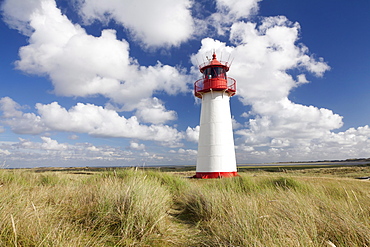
[0,0,370,167]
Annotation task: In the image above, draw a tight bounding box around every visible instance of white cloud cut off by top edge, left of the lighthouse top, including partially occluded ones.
[77,0,195,47]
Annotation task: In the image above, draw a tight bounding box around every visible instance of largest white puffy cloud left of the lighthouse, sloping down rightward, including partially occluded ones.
[5,0,188,111]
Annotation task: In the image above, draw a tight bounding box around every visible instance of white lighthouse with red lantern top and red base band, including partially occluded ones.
[194,53,238,178]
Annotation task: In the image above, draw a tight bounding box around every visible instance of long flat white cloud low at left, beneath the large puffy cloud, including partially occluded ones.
[0,98,183,145]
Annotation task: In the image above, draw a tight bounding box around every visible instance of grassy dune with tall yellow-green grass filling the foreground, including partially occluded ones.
[0,166,370,246]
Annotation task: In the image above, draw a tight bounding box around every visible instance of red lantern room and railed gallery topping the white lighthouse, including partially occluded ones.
[194,53,236,98]
